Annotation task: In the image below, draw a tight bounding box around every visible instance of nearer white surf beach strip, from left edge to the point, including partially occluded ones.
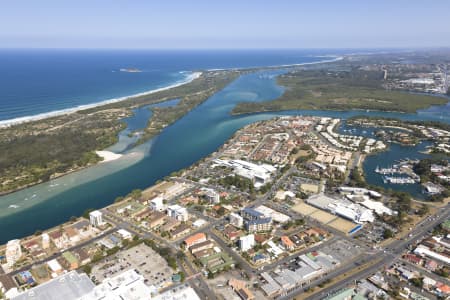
[0,72,203,129]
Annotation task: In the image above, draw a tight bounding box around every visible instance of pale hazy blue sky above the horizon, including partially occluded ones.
[0,0,450,48]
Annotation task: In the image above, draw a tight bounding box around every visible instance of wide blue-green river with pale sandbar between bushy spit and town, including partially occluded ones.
[0,50,450,243]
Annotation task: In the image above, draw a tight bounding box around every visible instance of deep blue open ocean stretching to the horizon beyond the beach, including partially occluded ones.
[0,50,342,121]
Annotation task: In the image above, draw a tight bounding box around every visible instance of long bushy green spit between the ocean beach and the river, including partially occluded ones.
[0,71,239,195]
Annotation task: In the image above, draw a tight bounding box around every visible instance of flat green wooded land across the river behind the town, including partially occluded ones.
[233,66,448,114]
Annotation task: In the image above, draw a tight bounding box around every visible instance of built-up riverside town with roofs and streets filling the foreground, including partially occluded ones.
[0,113,450,300]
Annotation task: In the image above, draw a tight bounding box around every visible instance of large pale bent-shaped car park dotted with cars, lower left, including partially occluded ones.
[91,244,173,288]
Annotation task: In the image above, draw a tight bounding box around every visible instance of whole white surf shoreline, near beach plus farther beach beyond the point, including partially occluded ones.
[0,56,344,129]
